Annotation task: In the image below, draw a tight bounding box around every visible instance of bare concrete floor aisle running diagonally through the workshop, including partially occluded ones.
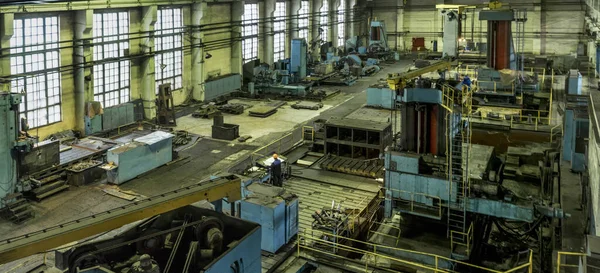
[0,60,411,272]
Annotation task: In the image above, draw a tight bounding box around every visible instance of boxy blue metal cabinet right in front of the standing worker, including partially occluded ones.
[240,183,299,253]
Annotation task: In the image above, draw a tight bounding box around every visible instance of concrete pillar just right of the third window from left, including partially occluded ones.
[191,2,207,101]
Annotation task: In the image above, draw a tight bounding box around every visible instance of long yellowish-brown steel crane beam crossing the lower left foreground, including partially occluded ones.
[0,176,241,264]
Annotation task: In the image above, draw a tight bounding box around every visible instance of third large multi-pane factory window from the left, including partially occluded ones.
[154,8,183,93]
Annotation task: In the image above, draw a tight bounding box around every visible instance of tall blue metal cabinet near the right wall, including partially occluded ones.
[562,95,590,172]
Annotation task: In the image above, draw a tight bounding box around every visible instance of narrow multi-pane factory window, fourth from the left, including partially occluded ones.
[242,4,258,63]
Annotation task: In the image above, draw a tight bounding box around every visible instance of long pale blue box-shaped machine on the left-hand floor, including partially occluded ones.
[106,131,173,184]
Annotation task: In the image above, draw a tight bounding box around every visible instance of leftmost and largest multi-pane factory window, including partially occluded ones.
[10,16,61,128]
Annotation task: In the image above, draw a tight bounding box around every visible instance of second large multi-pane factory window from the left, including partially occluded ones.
[93,12,130,107]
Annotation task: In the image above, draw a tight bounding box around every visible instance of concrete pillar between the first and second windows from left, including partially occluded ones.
[73,10,94,135]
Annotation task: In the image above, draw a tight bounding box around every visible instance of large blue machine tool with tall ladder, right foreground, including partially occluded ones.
[384,84,568,259]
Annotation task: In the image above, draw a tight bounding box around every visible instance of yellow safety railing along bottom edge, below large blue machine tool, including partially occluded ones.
[297,228,533,273]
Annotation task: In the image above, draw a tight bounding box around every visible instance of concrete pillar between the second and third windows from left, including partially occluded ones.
[140,6,158,119]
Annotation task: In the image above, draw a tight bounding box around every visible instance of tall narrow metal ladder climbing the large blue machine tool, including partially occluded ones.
[448,87,473,259]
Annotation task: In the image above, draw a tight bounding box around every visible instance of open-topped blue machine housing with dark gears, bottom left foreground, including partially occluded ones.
[65,205,261,273]
